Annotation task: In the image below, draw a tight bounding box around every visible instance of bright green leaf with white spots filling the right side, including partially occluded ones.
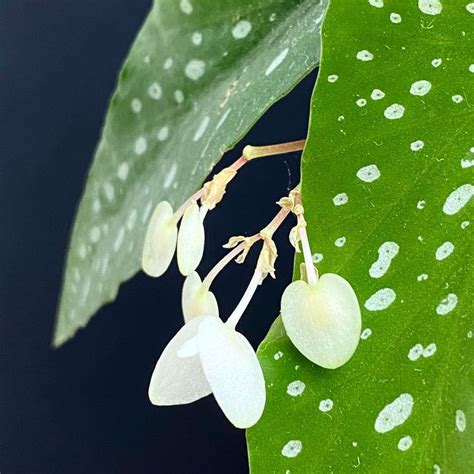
[248,0,474,474]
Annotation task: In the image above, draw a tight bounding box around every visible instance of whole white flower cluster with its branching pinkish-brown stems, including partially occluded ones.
[142,140,361,428]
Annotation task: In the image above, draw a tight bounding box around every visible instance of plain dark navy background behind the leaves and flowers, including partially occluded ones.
[0,0,315,474]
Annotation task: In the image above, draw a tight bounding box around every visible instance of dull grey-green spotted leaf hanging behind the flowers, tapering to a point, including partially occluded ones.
[54,0,327,345]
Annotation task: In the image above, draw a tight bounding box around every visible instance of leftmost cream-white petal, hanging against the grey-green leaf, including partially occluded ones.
[142,201,178,277]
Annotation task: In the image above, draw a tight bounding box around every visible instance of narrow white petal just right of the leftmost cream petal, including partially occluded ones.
[178,202,204,276]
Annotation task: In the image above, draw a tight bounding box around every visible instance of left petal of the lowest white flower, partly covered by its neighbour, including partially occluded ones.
[148,316,215,405]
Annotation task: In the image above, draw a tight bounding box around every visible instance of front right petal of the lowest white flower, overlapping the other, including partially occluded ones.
[193,318,265,428]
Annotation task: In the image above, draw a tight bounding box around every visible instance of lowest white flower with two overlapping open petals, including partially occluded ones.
[148,316,265,428]
